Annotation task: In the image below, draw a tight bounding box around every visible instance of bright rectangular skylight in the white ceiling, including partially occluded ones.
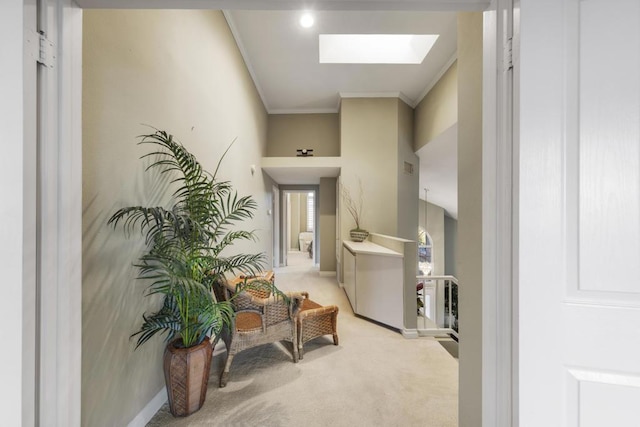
[319,34,438,64]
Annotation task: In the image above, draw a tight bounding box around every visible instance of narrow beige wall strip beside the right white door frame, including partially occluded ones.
[457,12,482,427]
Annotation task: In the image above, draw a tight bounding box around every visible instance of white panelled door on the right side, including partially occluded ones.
[516,0,640,427]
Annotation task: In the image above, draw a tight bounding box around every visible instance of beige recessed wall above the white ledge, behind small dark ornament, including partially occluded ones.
[267,114,340,157]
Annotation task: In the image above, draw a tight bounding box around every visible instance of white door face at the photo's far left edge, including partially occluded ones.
[0,0,26,426]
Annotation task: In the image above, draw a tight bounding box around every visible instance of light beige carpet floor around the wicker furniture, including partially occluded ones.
[148,254,458,427]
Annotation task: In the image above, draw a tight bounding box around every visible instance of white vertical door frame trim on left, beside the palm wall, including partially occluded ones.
[36,0,82,426]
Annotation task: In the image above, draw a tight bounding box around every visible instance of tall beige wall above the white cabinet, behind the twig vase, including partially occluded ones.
[340,98,400,240]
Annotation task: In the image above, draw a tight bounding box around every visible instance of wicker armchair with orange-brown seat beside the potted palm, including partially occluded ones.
[214,281,303,387]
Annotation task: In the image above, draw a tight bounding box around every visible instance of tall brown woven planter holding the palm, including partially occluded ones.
[164,339,213,417]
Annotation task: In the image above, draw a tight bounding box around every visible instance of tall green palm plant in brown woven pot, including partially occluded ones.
[109,130,264,416]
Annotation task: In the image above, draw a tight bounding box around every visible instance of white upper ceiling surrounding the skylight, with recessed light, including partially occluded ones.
[225,10,457,114]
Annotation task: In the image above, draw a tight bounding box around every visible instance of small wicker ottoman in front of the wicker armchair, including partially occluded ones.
[297,292,338,359]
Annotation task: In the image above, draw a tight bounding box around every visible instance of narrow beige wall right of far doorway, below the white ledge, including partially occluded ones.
[318,178,336,272]
